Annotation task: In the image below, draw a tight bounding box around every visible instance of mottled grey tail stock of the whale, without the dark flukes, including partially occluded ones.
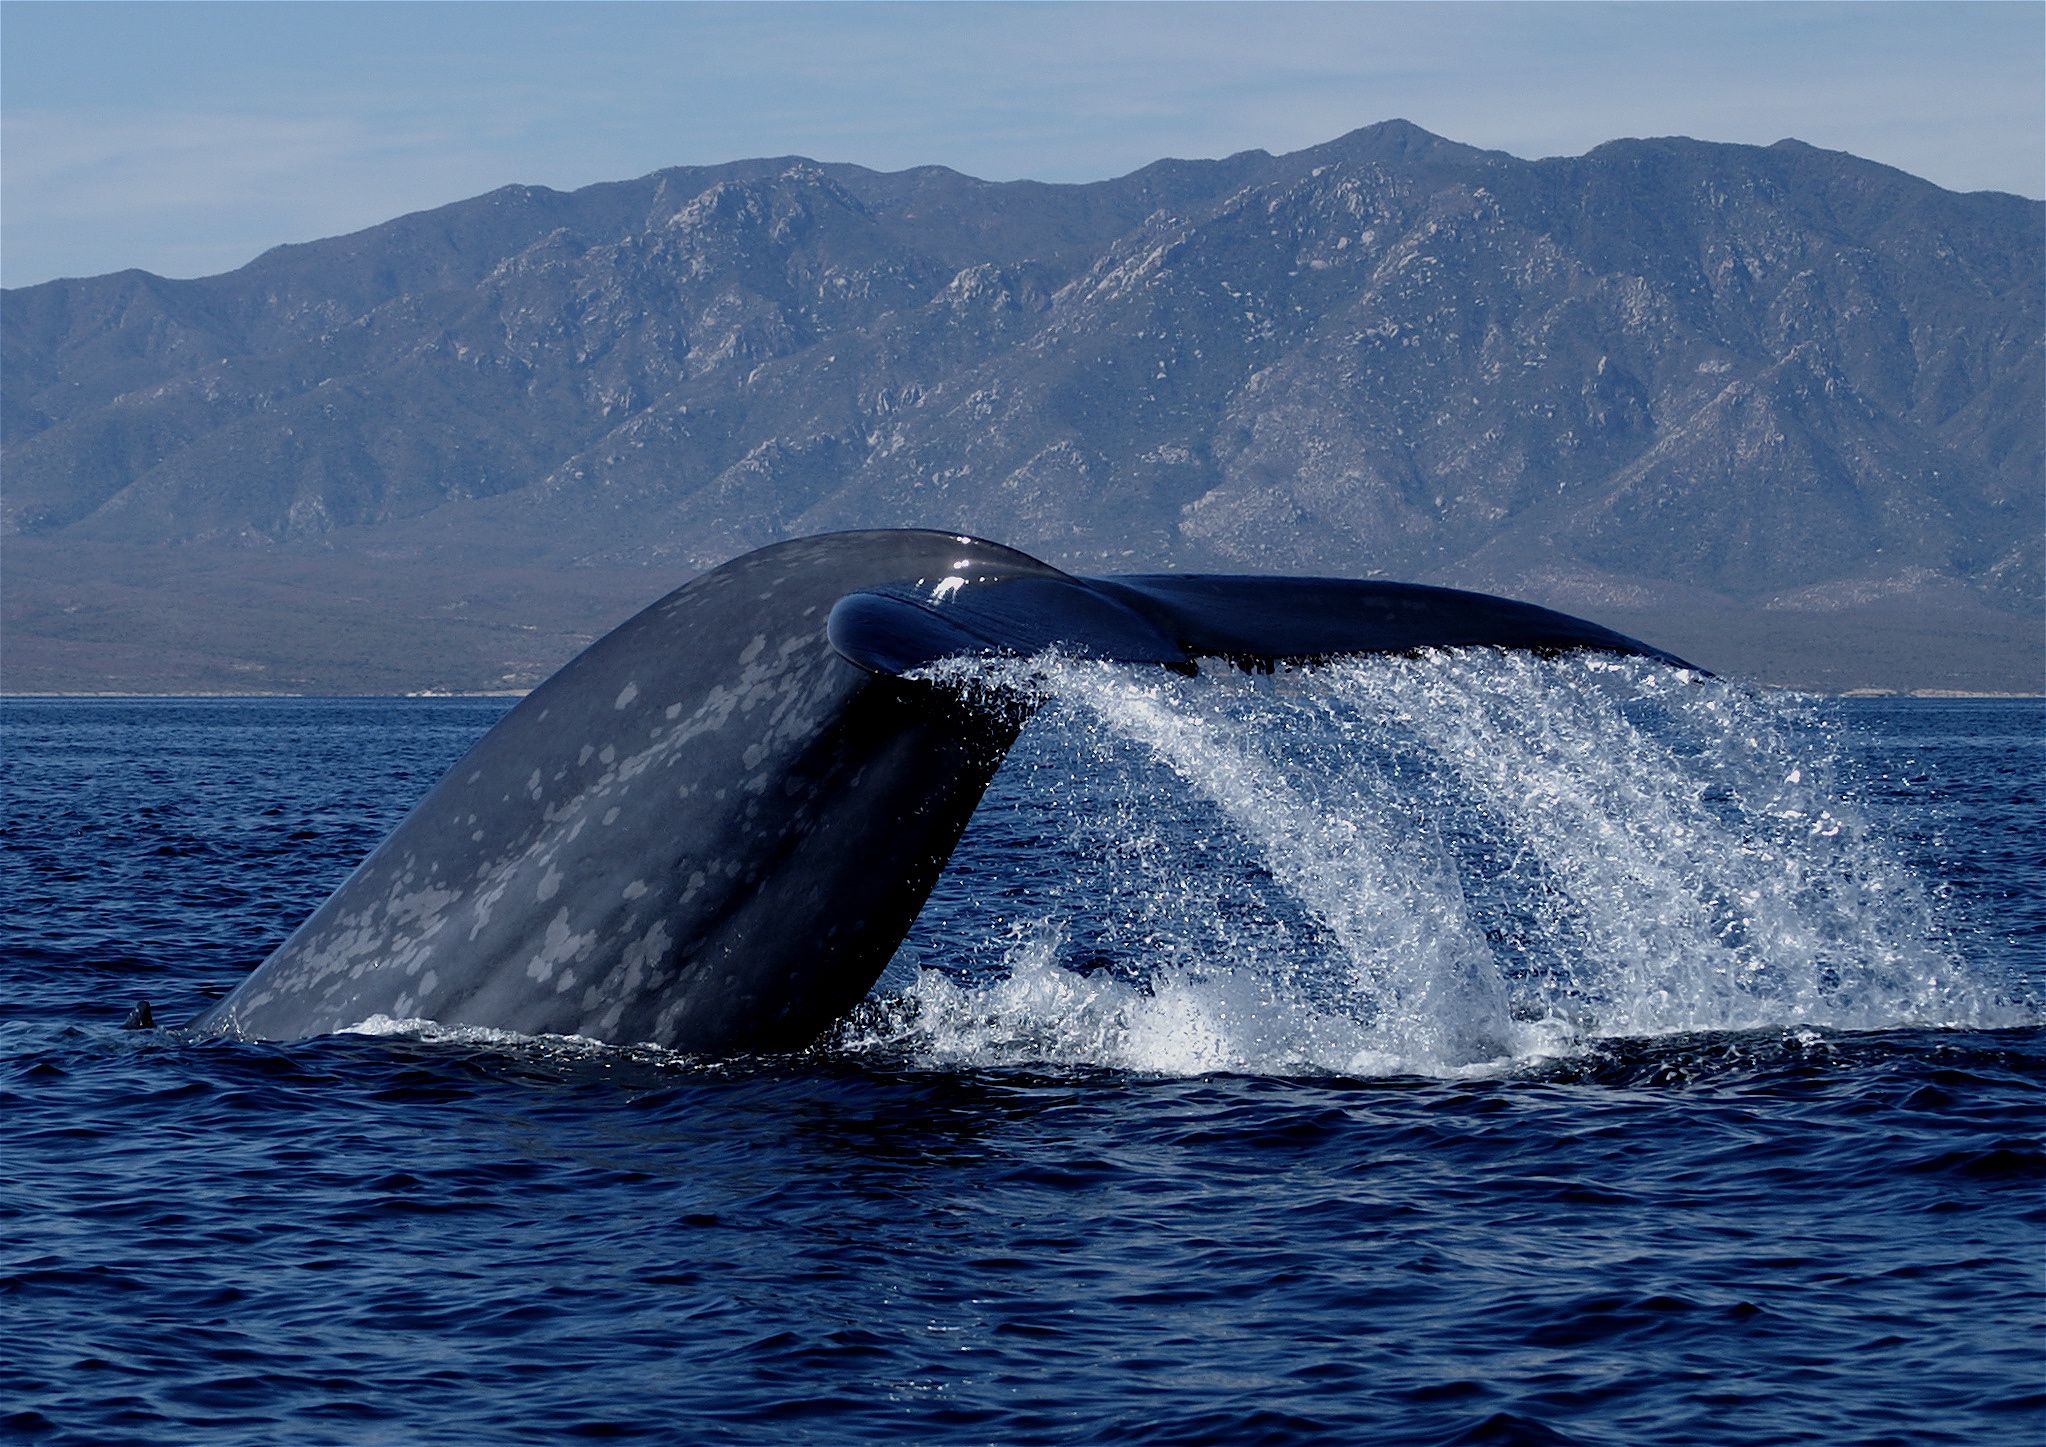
[194,532,1050,1052]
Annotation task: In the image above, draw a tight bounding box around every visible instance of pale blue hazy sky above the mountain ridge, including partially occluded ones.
[0,0,2046,287]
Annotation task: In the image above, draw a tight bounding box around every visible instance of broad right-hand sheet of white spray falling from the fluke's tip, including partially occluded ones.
[1330,655,1989,1034]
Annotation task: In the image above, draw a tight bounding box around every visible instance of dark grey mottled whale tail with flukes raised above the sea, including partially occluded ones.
[188,530,1692,1054]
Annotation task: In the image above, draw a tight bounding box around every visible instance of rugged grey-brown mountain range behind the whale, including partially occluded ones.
[0,121,2046,690]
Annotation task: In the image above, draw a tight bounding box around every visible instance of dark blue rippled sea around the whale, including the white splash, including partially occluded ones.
[0,663,2046,1443]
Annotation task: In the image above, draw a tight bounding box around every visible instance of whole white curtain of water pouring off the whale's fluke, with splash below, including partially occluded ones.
[841,651,2032,1075]
